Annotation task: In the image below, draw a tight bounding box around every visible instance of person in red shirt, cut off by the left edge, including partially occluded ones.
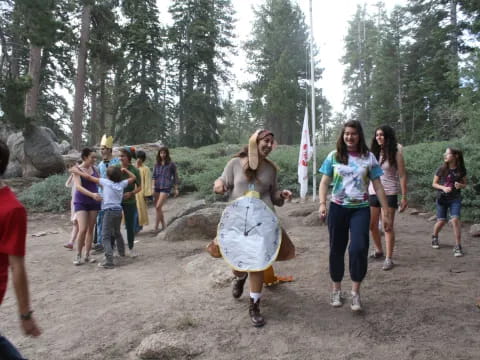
[0,140,41,360]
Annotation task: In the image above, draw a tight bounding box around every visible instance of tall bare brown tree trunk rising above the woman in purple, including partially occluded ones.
[72,5,92,150]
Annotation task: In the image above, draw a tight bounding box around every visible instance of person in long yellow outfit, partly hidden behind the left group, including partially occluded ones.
[135,151,153,233]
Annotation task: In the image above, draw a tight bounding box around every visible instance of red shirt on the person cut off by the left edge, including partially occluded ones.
[0,186,27,304]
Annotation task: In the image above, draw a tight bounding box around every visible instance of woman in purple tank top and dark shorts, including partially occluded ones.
[73,148,102,265]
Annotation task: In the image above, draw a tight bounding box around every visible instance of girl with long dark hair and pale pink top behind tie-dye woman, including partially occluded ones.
[368,125,408,270]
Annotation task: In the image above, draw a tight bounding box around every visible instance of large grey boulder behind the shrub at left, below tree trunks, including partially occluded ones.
[23,125,65,178]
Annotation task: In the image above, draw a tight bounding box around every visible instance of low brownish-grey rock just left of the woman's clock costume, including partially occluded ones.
[159,208,223,241]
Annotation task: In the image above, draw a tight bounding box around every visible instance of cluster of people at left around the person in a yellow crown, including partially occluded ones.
[64,135,178,269]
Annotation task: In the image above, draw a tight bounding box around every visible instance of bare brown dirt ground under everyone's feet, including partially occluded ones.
[0,197,480,360]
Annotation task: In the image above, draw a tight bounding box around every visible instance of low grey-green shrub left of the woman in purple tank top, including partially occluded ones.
[19,174,71,212]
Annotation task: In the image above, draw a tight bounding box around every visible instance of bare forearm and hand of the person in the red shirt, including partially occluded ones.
[8,255,41,336]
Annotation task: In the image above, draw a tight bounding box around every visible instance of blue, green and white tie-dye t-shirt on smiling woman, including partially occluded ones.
[319,150,383,208]
